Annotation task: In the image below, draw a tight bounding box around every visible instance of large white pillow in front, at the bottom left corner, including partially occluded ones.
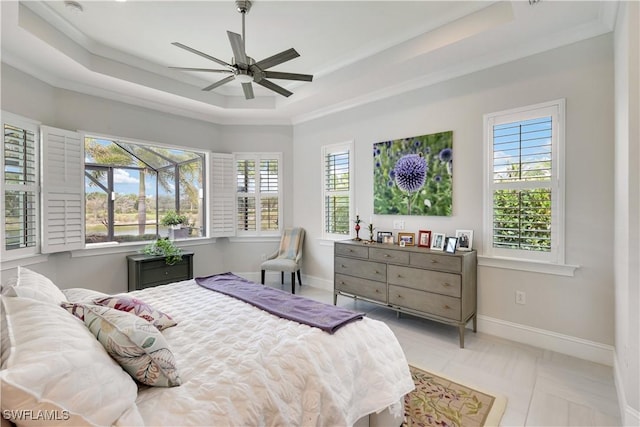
[0,297,137,426]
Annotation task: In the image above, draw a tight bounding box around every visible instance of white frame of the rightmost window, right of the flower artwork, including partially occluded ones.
[483,99,566,269]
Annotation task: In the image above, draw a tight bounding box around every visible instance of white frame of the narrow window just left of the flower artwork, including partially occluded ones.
[320,141,355,240]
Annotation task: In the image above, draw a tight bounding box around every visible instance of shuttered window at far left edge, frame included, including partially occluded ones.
[2,112,40,258]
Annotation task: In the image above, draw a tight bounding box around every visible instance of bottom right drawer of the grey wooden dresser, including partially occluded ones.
[389,285,462,321]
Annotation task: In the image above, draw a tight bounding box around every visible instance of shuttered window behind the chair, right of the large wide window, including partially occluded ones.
[235,153,282,236]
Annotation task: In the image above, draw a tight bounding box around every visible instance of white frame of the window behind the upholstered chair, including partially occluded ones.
[233,152,284,237]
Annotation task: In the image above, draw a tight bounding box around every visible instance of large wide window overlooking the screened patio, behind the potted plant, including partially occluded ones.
[84,137,206,243]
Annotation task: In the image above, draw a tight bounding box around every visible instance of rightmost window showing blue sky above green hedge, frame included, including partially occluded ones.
[484,100,564,264]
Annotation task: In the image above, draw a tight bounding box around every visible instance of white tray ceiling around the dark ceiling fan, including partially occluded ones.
[0,0,617,124]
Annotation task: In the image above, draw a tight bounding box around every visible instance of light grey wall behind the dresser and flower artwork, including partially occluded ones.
[293,35,614,352]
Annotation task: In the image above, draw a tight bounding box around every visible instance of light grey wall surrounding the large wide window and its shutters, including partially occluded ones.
[1,64,293,293]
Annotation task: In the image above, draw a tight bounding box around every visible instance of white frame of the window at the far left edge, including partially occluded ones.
[0,111,42,263]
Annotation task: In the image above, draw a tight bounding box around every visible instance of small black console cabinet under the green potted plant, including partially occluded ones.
[127,252,193,292]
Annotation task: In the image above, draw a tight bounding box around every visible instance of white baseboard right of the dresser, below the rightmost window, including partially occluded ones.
[478,315,614,366]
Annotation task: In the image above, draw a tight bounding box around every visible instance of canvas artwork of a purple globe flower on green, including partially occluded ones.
[373,131,453,216]
